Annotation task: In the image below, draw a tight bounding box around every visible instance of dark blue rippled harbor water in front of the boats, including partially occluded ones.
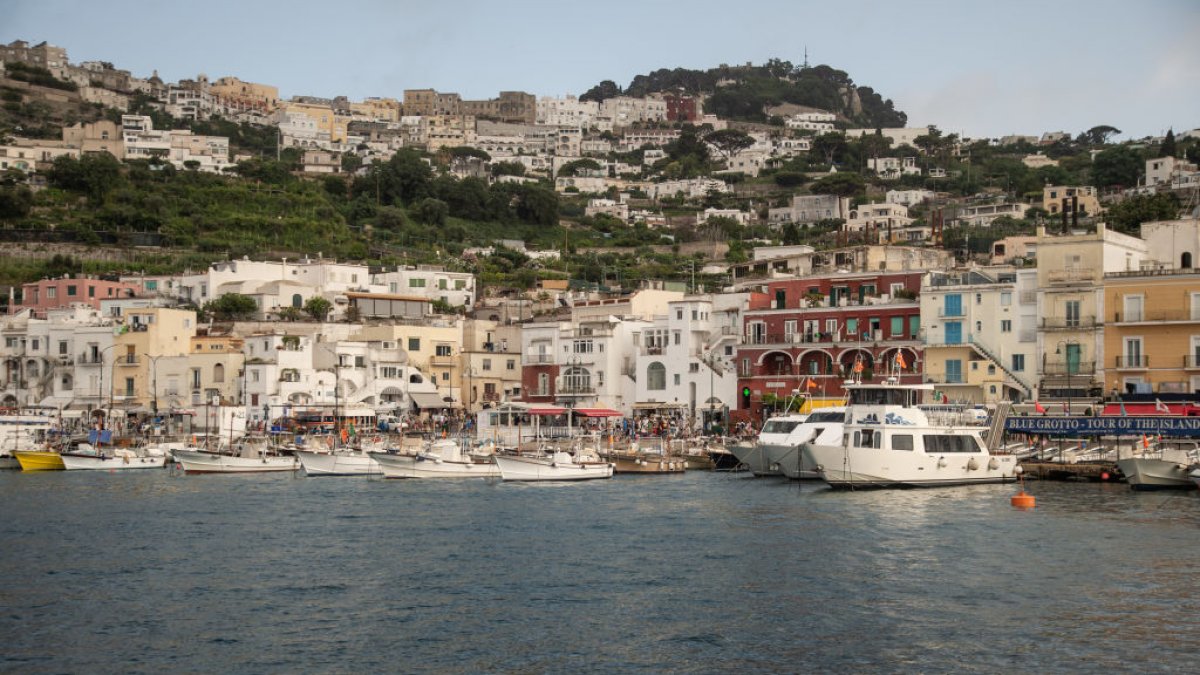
[0,471,1200,673]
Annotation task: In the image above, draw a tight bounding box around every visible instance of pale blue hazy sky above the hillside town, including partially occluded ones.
[0,0,1200,139]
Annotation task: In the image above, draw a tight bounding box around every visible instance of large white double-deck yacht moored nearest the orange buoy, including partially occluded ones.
[804,378,1016,488]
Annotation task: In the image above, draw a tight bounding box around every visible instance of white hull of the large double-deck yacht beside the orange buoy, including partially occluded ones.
[804,444,1016,488]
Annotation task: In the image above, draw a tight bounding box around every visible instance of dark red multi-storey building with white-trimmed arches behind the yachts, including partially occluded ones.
[737,271,924,420]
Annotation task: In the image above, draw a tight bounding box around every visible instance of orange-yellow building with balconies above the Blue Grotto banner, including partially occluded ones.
[1104,269,1200,394]
